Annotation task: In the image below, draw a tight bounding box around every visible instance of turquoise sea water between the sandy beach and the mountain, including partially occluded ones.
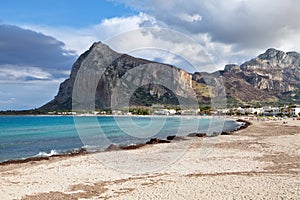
[0,116,239,162]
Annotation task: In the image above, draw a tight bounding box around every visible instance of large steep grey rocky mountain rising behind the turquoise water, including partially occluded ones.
[40,42,195,110]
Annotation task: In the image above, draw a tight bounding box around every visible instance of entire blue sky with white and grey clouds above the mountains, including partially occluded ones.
[0,0,300,110]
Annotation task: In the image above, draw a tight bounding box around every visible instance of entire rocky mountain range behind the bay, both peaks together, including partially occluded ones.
[40,42,300,110]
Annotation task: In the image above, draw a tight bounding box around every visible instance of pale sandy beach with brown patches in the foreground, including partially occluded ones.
[0,119,300,200]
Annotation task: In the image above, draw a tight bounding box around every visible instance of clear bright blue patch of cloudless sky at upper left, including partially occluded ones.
[0,0,137,28]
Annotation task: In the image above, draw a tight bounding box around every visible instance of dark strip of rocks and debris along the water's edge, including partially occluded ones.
[0,115,251,166]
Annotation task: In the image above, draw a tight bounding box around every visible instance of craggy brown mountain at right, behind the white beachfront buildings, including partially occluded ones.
[193,49,300,104]
